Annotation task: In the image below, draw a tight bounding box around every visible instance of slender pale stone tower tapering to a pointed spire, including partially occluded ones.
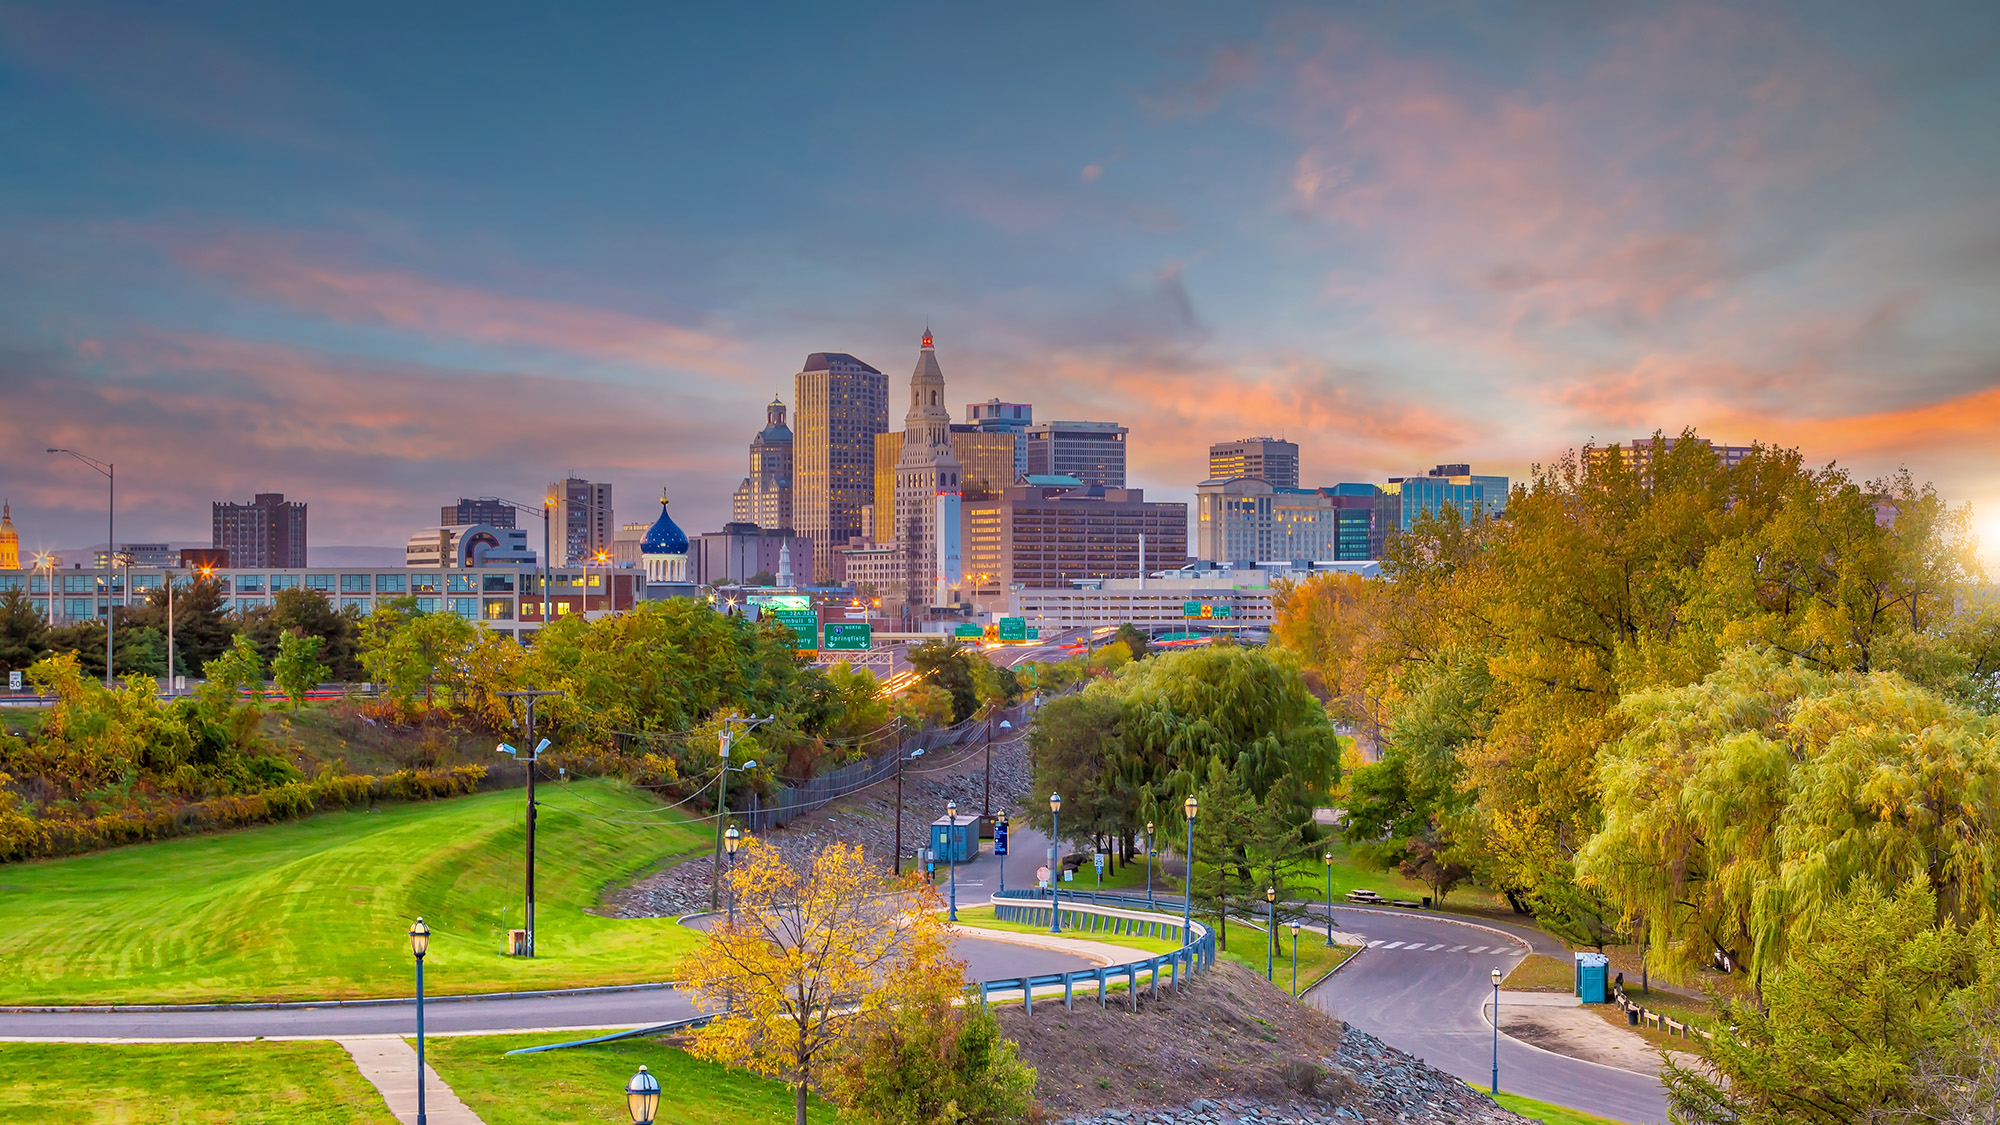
[896,328,962,605]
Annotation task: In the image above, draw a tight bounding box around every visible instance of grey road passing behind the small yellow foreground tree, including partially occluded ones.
[0,939,1094,1039]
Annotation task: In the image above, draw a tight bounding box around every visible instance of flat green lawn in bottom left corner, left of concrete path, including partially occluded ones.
[0,1043,398,1125]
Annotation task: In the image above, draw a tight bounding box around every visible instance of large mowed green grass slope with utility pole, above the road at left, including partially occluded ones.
[0,781,710,1005]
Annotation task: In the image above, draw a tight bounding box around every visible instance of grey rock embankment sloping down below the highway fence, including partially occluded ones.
[598,739,1028,919]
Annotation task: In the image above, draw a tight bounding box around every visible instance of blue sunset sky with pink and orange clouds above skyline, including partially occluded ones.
[0,0,2000,560]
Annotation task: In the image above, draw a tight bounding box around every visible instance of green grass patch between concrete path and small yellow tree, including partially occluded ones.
[424,1031,834,1125]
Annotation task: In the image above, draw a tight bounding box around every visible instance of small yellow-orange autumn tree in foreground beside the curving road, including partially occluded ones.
[688,839,964,1125]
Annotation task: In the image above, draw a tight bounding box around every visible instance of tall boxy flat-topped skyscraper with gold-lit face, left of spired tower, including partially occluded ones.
[792,352,888,581]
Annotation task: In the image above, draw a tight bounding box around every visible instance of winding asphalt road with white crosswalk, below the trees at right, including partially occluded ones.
[1308,907,1666,1125]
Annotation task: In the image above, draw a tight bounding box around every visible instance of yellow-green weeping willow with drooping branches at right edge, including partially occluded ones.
[1578,653,2000,983]
